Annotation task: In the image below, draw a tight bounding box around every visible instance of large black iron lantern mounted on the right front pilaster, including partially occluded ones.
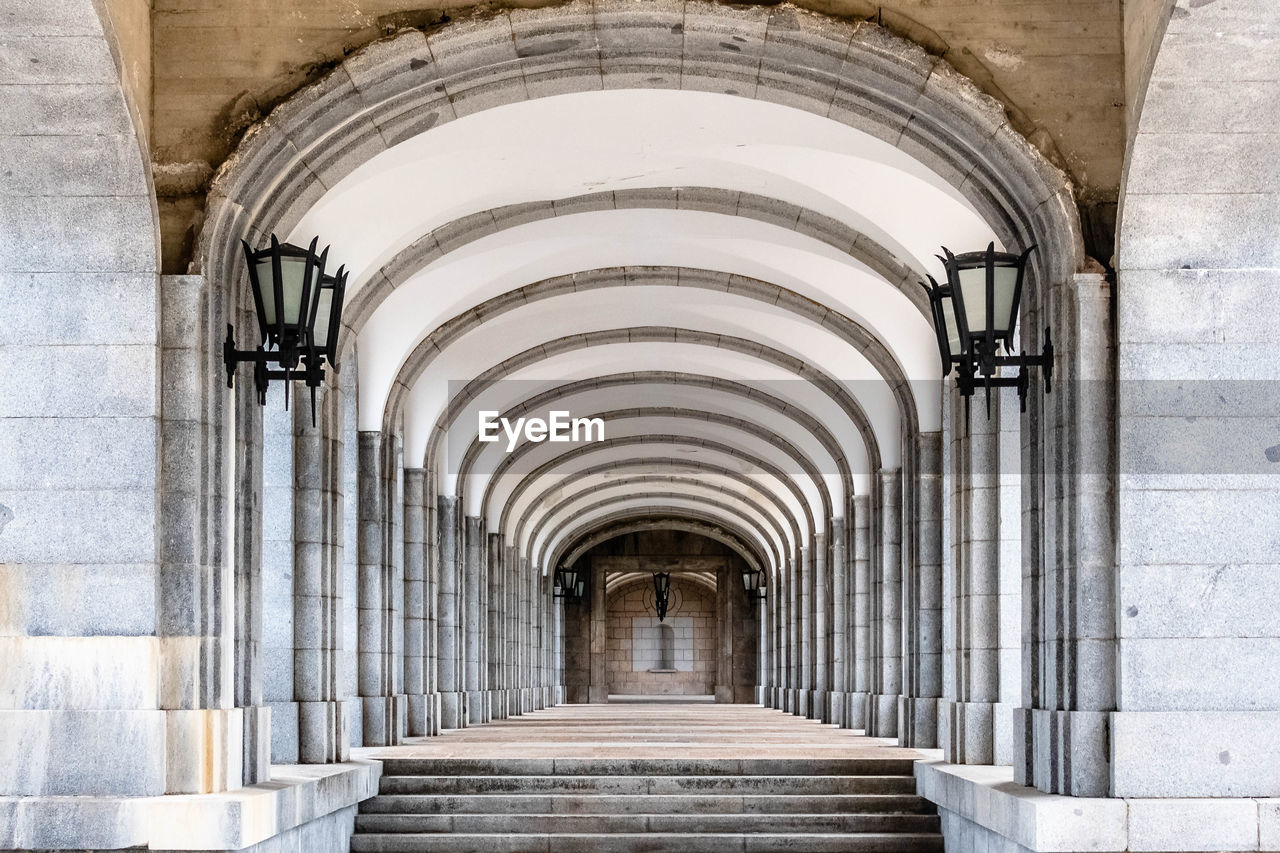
[924,243,1053,416]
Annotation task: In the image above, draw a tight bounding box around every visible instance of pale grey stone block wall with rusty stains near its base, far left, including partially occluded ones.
[0,0,167,795]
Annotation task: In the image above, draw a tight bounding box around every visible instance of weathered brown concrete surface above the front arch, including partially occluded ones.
[152,0,1125,270]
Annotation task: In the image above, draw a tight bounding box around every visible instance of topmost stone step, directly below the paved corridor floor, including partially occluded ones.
[373,758,915,776]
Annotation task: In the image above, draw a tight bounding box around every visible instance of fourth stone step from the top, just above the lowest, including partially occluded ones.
[356,813,940,835]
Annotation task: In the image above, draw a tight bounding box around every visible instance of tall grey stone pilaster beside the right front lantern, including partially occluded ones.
[1012,274,1116,797]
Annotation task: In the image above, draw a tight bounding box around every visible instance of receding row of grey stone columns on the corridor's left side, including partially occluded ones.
[257,384,563,763]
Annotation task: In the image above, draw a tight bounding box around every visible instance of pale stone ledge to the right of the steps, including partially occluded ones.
[915,751,1280,853]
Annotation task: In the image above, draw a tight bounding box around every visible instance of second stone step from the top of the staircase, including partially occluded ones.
[379,775,915,795]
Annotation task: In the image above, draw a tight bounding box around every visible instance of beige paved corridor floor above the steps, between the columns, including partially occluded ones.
[352,703,923,758]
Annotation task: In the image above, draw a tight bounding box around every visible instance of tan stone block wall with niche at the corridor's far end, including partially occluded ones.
[605,575,721,695]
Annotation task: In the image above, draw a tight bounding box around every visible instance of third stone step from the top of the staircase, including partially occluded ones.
[360,793,933,815]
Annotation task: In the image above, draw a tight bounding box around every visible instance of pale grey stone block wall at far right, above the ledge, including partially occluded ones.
[1111,0,1280,797]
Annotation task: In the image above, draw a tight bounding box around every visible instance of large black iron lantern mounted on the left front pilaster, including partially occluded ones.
[223,234,347,424]
